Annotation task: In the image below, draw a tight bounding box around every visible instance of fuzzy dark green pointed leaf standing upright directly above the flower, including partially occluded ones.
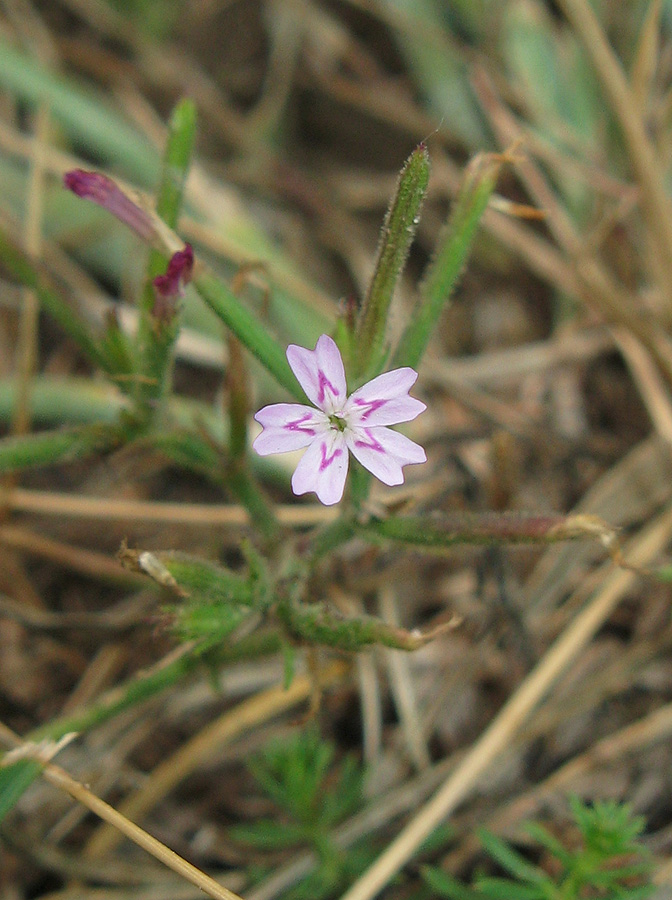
[354,144,429,381]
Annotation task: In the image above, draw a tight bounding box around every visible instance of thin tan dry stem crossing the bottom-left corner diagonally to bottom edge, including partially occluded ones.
[1,726,240,900]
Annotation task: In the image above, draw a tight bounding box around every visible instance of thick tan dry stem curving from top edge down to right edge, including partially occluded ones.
[559,0,672,302]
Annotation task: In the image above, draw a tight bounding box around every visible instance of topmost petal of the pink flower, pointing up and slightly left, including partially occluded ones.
[287,334,347,416]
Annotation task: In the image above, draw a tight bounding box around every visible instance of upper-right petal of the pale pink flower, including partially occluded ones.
[343,367,427,428]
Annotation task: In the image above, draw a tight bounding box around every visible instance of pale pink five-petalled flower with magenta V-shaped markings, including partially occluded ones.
[253,334,427,506]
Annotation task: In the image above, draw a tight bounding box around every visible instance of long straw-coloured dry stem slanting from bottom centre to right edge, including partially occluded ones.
[342,507,672,900]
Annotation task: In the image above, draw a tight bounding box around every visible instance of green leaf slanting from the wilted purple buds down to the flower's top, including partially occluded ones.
[193,272,306,403]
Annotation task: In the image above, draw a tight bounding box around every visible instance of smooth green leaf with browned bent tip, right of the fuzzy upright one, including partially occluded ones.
[394,153,504,369]
